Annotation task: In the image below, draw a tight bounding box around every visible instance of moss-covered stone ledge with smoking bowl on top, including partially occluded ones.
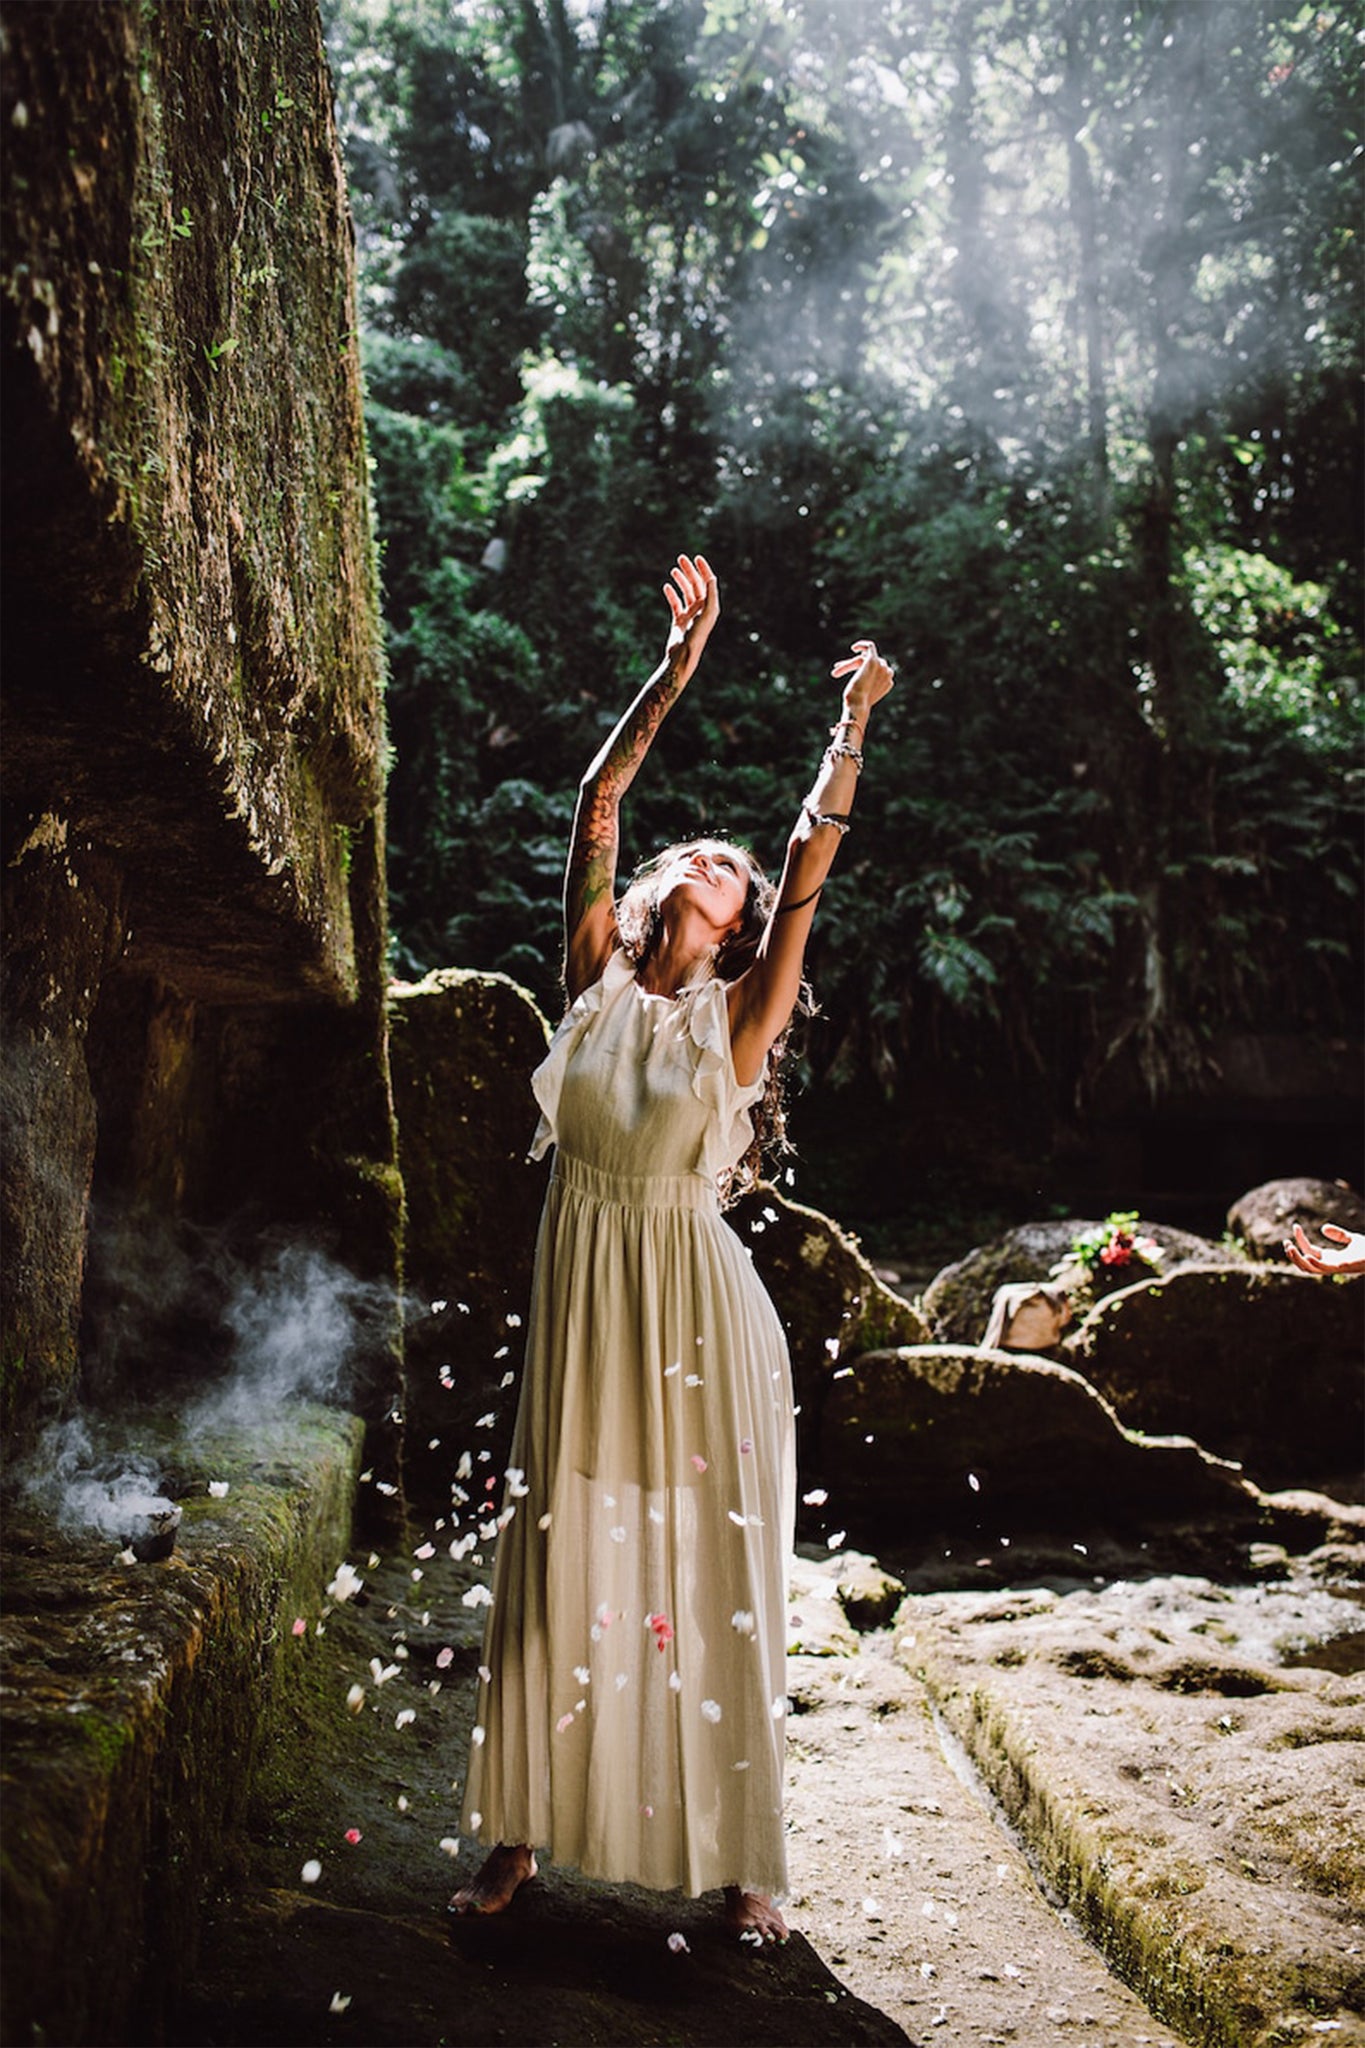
[0,1409,360,2042]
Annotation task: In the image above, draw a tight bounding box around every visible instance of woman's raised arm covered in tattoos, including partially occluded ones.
[565,555,720,1001]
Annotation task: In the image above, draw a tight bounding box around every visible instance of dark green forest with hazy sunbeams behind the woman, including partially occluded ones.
[327,0,1365,1237]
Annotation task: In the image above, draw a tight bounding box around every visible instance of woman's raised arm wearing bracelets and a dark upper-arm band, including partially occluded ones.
[729,641,894,1083]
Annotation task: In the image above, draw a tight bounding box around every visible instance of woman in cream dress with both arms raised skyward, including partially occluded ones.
[450,555,892,1942]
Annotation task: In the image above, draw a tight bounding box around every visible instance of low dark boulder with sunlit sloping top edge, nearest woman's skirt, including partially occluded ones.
[821,1343,1250,1536]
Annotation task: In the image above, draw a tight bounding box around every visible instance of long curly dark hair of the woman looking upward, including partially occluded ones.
[616,838,814,1208]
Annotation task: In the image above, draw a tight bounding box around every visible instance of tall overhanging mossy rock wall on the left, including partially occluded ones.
[0,0,401,1464]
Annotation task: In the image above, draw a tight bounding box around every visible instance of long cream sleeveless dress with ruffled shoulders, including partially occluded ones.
[463,952,796,1896]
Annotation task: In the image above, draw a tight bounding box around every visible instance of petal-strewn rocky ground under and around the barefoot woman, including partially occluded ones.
[172,1474,1365,2048]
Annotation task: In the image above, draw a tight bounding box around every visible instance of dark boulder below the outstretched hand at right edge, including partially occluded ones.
[1064,1266,1365,1485]
